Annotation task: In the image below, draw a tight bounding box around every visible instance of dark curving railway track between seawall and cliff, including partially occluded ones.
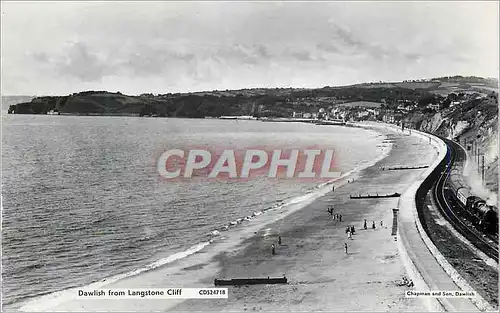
[432,137,498,263]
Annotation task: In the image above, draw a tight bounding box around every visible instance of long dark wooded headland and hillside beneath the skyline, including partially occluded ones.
[9,76,498,118]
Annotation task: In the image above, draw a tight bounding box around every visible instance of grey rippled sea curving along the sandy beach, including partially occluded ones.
[2,114,387,308]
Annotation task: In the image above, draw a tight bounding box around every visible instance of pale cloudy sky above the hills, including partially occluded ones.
[1,1,499,96]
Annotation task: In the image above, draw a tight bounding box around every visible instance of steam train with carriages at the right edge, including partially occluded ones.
[448,175,498,234]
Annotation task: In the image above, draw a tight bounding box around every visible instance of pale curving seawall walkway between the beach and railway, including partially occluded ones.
[388,125,493,311]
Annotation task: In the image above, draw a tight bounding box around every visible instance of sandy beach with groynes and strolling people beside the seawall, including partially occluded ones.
[6,123,437,312]
